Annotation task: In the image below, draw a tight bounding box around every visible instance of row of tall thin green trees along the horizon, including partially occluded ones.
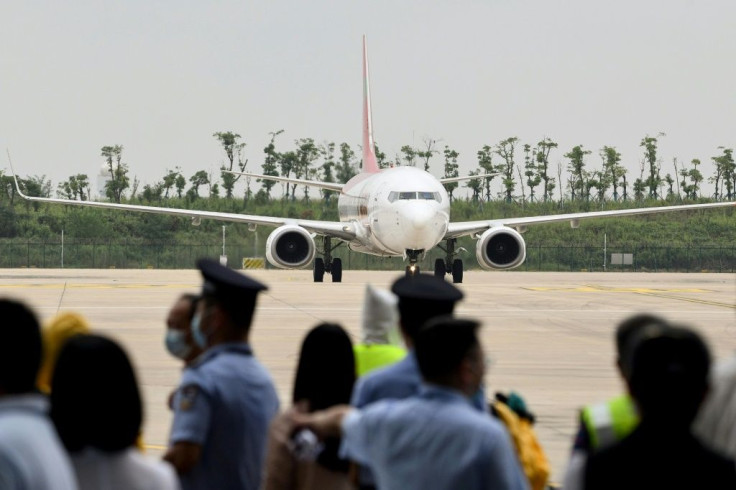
[0,130,736,207]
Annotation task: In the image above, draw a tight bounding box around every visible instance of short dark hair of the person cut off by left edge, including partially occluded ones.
[0,299,42,394]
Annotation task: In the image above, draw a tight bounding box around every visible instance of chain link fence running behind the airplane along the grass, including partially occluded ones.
[0,239,736,272]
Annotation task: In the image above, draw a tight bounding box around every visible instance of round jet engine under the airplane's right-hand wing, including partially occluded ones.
[475,226,526,270]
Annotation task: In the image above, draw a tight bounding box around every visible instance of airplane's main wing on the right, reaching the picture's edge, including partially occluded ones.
[445,202,736,239]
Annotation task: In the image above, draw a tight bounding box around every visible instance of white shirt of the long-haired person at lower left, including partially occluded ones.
[72,448,180,490]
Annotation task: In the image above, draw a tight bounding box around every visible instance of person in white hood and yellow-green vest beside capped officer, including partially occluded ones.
[355,284,406,376]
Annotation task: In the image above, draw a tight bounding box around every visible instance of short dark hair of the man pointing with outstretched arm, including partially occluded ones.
[414,316,480,381]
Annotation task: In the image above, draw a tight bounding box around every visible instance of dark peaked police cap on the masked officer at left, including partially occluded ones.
[197,259,268,302]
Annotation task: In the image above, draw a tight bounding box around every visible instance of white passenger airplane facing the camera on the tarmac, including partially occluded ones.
[8,37,736,283]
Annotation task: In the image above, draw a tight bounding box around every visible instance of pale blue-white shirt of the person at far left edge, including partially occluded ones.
[0,394,77,490]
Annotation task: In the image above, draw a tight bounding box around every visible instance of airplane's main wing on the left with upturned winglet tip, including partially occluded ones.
[10,163,356,241]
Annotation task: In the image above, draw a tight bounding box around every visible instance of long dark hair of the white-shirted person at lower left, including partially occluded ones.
[51,335,143,452]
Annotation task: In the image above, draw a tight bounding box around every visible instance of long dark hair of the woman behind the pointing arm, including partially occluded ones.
[293,323,355,472]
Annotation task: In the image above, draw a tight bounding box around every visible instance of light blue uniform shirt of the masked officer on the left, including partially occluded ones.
[170,343,279,490]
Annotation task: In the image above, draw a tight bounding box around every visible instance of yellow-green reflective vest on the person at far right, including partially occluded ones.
[583,395,639,450]
